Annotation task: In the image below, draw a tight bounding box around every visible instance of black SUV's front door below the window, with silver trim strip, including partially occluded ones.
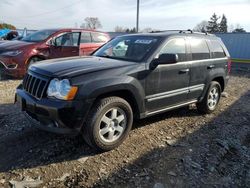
[146,63,189,111]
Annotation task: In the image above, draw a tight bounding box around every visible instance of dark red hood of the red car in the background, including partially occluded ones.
[0,40,34,51]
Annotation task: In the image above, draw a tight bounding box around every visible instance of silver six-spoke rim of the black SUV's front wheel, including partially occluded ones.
[99,107,127,142]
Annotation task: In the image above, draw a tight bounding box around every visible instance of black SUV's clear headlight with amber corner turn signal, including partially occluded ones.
[47,78,78,100]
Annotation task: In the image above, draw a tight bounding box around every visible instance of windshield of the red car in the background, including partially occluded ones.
[22,30,57,42]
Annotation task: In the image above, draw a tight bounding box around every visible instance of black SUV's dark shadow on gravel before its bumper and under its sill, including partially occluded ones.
[0,104,199,172]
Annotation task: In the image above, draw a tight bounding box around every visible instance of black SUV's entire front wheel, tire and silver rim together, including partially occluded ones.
[83,97,133,151]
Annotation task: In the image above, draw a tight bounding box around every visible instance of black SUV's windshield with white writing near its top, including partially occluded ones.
[93,35,158,62]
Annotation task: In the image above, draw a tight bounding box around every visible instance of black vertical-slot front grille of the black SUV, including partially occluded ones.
[23,74,48,99]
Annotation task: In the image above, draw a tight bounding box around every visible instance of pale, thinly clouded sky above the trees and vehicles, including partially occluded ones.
[0,0,250,31]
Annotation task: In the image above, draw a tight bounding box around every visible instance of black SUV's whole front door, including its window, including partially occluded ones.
[146,37,190,112]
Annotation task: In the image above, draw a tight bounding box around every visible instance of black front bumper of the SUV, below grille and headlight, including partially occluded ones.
[16,88,92,134]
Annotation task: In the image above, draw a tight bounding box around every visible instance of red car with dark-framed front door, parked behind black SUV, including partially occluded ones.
[0,29,110,78]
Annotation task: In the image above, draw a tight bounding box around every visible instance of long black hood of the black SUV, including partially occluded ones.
[29,56,137,77]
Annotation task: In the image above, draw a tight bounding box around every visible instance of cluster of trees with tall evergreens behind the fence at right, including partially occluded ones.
[193,13,246,33]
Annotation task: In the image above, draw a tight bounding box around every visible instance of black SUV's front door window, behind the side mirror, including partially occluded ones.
[159,38,187,62]
